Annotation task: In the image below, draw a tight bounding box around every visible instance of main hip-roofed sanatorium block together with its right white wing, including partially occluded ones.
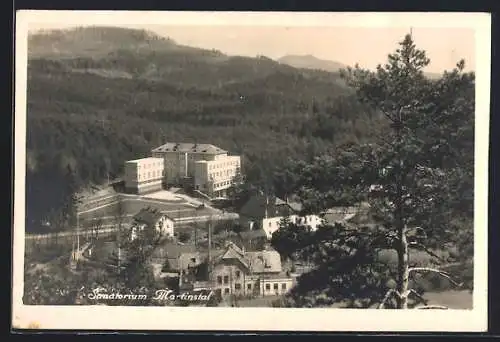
[151,143,241,196]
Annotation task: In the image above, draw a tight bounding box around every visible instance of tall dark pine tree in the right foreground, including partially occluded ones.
[284,35,474,309]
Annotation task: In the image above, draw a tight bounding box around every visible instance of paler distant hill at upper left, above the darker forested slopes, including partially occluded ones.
[28,27,352,88]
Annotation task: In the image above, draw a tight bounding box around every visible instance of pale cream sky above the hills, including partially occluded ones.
[25,13,476,73]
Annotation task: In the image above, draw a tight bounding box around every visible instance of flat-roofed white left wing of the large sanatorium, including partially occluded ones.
[124,158,164,194]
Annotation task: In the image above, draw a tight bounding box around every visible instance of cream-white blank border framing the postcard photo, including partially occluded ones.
[12,10,491,332]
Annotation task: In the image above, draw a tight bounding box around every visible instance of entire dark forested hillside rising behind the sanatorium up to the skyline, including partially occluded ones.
[27,27,382,230]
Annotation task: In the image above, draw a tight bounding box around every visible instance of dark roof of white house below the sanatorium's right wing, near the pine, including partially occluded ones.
[240,195,297,219]
